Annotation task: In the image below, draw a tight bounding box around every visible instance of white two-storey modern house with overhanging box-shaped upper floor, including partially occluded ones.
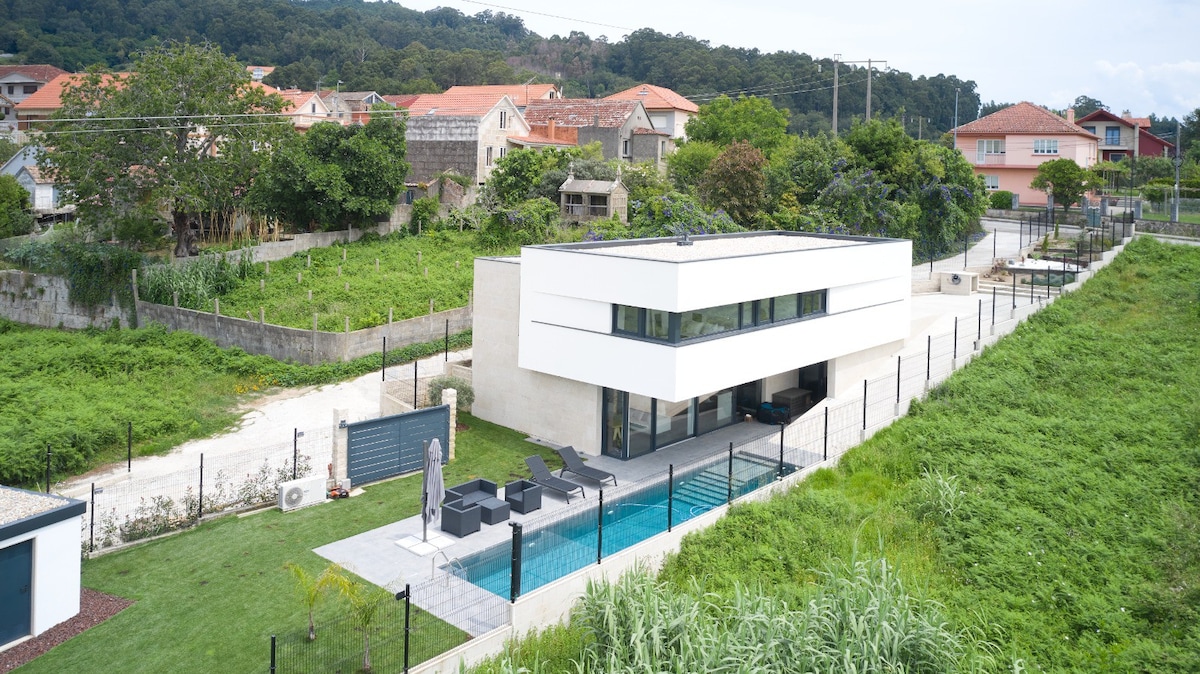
[472,231,912,458]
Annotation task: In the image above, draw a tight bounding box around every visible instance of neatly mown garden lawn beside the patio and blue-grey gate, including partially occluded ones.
[18,414,557,674]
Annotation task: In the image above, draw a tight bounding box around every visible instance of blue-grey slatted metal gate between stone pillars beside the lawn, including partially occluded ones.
[346,405,450,485]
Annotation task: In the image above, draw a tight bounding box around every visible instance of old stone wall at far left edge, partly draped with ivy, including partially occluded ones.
[0,270,130,330]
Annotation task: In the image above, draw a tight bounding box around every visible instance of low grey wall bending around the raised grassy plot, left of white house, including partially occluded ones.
[136,300,472,365]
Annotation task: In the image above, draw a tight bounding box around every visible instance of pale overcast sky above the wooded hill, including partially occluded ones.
[398,0,1200,119]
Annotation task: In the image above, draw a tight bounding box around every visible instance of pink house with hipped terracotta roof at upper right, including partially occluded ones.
[952,102,1099,205]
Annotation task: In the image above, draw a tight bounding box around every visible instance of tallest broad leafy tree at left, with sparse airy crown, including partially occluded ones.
[38,43,286,257]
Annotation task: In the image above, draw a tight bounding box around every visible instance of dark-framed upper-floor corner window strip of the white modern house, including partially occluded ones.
[612,290,827,344]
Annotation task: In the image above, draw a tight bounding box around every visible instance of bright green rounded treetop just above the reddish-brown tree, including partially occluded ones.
[685,96,788,155]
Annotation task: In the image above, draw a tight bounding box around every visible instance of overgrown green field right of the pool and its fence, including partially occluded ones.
[484,237,1200,672]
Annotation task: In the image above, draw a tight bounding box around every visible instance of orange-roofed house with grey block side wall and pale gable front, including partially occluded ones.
[404,94,529,185]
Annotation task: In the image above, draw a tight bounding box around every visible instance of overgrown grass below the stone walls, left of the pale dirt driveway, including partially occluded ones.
[0,319,470,488]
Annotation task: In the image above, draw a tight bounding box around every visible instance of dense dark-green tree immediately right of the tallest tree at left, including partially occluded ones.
[251,106,408,229]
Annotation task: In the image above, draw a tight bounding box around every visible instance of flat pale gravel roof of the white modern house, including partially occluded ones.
[533,231,900,263]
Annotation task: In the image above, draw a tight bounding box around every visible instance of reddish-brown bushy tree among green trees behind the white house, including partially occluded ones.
[700,140,767,227]
